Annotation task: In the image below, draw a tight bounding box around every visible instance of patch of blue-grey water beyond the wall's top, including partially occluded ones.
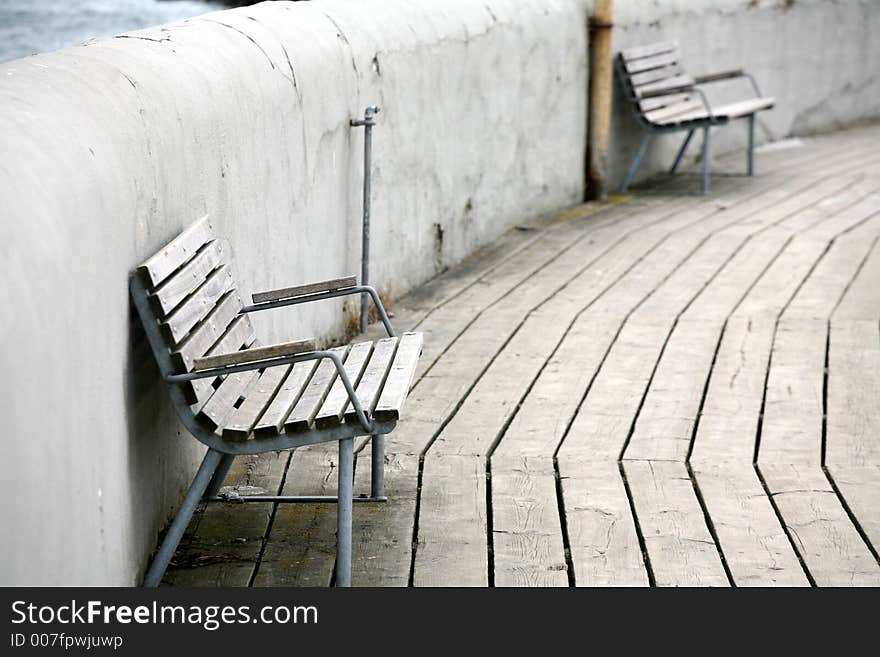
[0,0,224,62]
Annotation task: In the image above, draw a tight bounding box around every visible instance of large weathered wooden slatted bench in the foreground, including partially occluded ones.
[130,217,422,586]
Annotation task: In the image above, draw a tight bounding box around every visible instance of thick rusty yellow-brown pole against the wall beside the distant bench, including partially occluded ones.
[586,0,614,201]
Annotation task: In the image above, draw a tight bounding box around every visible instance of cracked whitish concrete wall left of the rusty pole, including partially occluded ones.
[0,0,586,584]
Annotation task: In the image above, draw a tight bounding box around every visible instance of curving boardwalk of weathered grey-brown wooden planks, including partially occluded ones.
[165,126,880,586]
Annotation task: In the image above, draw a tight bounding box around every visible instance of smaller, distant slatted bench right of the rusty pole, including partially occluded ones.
[615,41,774,194]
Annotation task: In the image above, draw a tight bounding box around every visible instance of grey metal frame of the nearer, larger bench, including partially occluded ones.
[130,272,397,587]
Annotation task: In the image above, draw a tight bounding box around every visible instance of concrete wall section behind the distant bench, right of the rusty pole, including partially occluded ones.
[609,0,880,184]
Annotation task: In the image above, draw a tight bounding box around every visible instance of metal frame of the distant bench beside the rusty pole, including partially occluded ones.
[614,53,761,194]
